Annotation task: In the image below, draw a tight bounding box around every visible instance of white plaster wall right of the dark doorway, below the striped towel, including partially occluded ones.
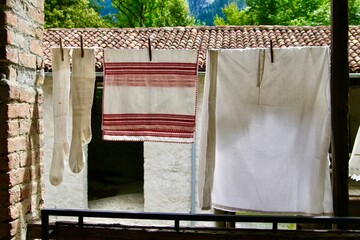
[144,76,204,213]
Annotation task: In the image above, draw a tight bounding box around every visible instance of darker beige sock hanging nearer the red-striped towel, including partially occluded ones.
[69,48,95,173]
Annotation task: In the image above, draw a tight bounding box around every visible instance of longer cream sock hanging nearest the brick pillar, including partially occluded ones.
[49,48,70,186]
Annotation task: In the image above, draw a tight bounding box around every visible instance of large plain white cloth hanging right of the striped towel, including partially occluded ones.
[198,47,332,214]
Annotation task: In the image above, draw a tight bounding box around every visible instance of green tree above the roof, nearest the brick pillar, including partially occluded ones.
[44,0,110,28]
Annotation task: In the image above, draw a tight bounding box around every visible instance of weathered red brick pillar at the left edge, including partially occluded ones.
[0,0,44,239]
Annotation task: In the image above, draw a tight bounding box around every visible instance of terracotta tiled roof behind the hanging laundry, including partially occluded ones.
[43,26,360,72]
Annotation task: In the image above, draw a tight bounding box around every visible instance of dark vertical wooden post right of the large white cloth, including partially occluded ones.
[331,0,349,216]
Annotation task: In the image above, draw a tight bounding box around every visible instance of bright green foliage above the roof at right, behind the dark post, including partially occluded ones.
[214,0,360,26]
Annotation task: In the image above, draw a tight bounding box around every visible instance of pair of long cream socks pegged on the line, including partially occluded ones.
[50,48,95,186]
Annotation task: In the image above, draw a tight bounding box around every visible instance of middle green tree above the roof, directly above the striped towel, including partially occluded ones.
[113,0,195,27]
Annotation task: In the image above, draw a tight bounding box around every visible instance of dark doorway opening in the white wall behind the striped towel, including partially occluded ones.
[88,79,144,201]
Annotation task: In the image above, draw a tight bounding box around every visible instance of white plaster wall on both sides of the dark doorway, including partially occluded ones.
[43,75,204,213]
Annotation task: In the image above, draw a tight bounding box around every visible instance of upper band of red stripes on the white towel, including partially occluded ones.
[104,62,197,87]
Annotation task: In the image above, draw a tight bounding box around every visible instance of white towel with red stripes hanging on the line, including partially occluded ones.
[102,49,198,143]
